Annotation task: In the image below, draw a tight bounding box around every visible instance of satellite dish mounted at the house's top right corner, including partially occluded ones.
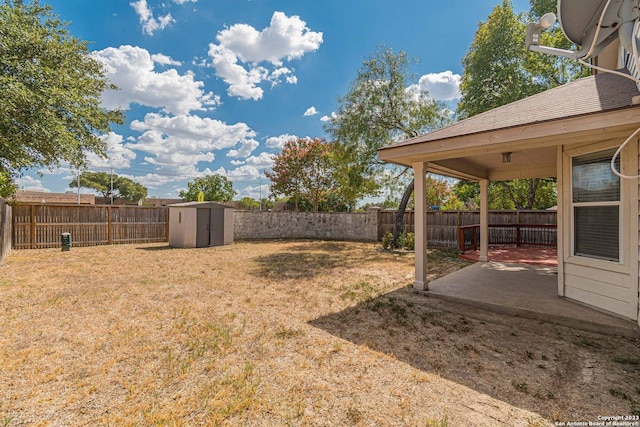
[527,0,638,60]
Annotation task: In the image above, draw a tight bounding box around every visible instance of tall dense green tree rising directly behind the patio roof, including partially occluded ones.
[457,0,588,209]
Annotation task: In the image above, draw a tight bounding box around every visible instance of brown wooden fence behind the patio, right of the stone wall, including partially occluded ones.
[378,210,557,250]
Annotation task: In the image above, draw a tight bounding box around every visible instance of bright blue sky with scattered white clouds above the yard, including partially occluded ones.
[18,0,528,198]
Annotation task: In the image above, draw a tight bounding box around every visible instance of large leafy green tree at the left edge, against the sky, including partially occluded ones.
[0,0,124,196]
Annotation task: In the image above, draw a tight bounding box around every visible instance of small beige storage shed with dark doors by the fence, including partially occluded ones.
[169,202,234,248]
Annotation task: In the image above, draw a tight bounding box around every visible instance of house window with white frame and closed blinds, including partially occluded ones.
[571,150,620,262]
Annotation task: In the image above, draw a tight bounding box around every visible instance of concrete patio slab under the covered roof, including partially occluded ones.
[427,262,640,338]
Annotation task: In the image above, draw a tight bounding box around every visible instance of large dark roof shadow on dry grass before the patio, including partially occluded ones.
[309,287,640,420]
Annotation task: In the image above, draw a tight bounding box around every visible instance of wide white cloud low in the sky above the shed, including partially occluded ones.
[126,113,259,181]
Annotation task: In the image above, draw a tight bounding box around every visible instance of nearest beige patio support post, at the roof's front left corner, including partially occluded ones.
[413,162,429,291]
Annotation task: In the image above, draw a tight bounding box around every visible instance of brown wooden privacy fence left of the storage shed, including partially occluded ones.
[12,204,169,249]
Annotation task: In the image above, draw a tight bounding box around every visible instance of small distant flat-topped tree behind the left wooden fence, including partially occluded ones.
[69,171,147,202]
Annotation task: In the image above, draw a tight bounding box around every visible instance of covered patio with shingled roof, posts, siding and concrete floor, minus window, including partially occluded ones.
[378,74,640,330]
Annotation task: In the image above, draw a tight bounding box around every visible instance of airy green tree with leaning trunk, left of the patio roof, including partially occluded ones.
[325,46,448,241]
